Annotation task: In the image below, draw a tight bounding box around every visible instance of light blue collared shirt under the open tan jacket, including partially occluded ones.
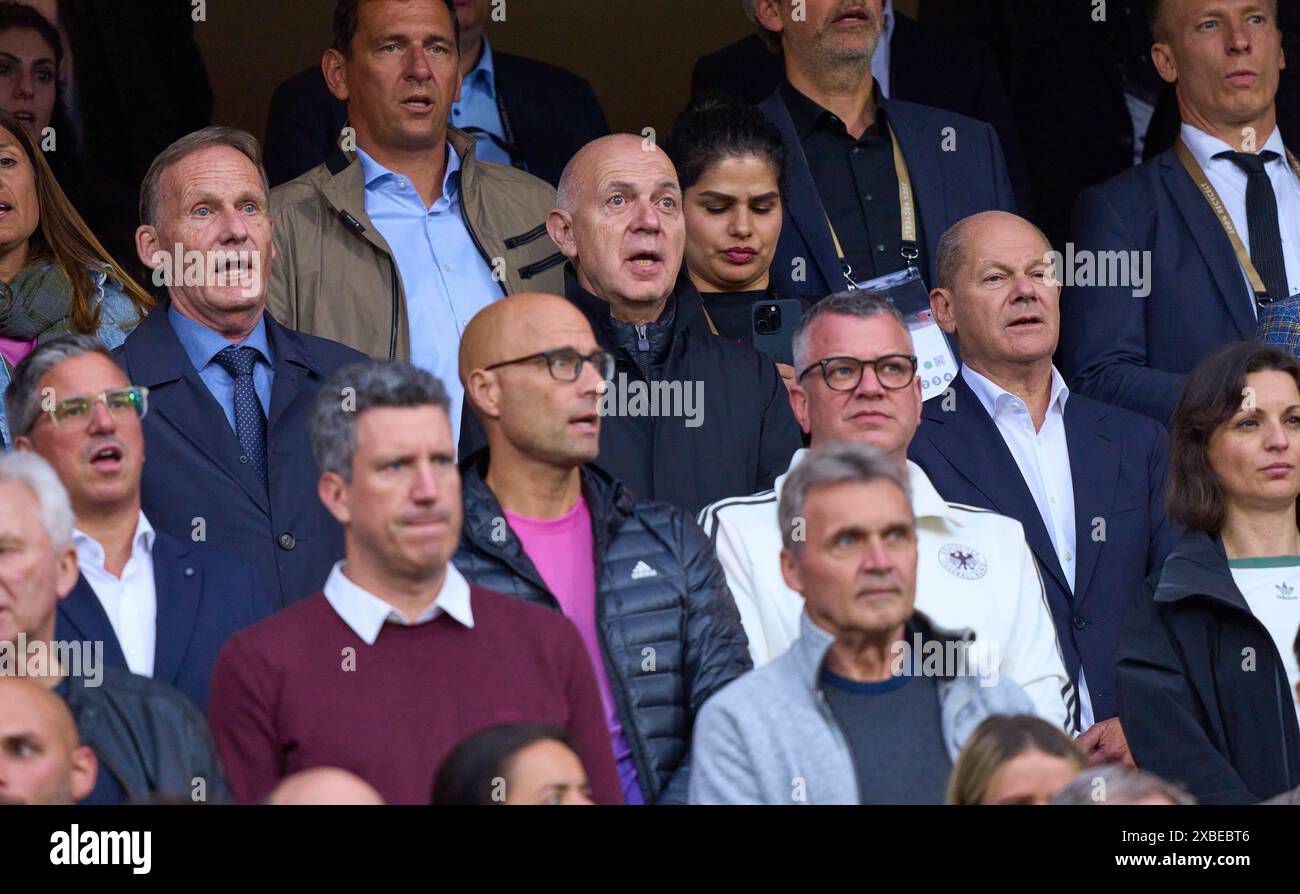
[356,143,504,438]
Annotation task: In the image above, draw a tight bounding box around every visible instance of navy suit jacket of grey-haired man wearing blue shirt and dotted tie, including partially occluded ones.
[113,301,367,608]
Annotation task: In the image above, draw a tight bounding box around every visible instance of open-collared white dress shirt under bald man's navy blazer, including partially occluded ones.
[962,366,1093,733]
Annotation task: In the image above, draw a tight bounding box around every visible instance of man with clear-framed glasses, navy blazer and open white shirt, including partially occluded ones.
[5,335,270,711]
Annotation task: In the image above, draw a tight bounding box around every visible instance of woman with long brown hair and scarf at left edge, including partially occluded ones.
[0,112,153,443]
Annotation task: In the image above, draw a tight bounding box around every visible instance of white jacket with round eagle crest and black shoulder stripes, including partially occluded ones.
[699,450,1074,730]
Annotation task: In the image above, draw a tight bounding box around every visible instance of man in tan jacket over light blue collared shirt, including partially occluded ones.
[268,0,564,444]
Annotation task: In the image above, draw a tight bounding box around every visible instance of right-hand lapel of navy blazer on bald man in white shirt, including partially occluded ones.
[1065,396,1119,607]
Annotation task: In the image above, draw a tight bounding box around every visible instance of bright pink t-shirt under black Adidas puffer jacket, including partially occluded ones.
[506,495,645,804]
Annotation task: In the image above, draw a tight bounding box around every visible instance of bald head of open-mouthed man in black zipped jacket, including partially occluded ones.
[546,134,686,324]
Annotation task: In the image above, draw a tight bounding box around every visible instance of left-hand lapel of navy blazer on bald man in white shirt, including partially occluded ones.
[924,376,1071,593]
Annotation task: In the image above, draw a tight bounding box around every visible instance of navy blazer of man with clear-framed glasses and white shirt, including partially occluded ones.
[56,531,270,716]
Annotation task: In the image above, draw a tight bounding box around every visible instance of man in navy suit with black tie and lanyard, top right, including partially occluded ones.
[1061,0,1300,425]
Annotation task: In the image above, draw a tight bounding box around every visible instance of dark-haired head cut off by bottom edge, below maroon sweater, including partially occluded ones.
[432,724,592,804]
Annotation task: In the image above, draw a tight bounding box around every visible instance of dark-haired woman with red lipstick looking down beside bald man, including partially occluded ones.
[663,99,787,372]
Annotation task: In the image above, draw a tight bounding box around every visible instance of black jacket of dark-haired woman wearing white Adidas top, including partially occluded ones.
[1115,531,1300,804]
